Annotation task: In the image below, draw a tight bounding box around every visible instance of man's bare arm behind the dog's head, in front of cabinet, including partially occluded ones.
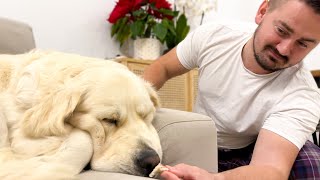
[143,48,189,89]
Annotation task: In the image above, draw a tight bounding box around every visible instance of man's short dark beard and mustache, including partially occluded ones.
[253,25,289,73]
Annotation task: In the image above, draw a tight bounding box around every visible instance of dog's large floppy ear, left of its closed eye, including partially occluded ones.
[21,87,82,137]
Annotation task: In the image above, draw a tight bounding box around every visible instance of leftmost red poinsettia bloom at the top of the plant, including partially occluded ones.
[108,0,143,24]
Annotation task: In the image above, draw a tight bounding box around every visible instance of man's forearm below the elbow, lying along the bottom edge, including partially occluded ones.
[213,165,288,180]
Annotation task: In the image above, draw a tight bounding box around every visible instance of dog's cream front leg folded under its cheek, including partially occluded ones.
[0,129,93,180]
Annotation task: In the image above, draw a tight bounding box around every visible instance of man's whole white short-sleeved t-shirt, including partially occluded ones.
[177,24,320,149]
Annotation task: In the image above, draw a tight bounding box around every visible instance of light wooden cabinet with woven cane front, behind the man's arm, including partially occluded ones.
[117,58,198,111]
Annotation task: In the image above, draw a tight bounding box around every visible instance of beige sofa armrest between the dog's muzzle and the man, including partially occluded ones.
[153,108,218,172]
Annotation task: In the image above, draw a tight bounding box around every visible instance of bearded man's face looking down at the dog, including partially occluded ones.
[253,0,320,72]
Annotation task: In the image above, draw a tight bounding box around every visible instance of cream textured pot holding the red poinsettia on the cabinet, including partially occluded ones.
[133,38,162,60]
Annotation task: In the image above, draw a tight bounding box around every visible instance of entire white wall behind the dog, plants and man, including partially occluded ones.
[0,0,320,69]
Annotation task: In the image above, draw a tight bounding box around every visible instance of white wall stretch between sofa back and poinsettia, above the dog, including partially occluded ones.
[0,0,119,58]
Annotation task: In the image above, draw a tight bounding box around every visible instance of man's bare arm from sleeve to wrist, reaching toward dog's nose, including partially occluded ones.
[216,129,299,180]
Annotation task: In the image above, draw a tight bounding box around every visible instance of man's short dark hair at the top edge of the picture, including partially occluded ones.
[267,0,320,14]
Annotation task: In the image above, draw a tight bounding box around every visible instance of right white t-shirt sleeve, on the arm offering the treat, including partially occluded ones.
[262,72,320,149]
